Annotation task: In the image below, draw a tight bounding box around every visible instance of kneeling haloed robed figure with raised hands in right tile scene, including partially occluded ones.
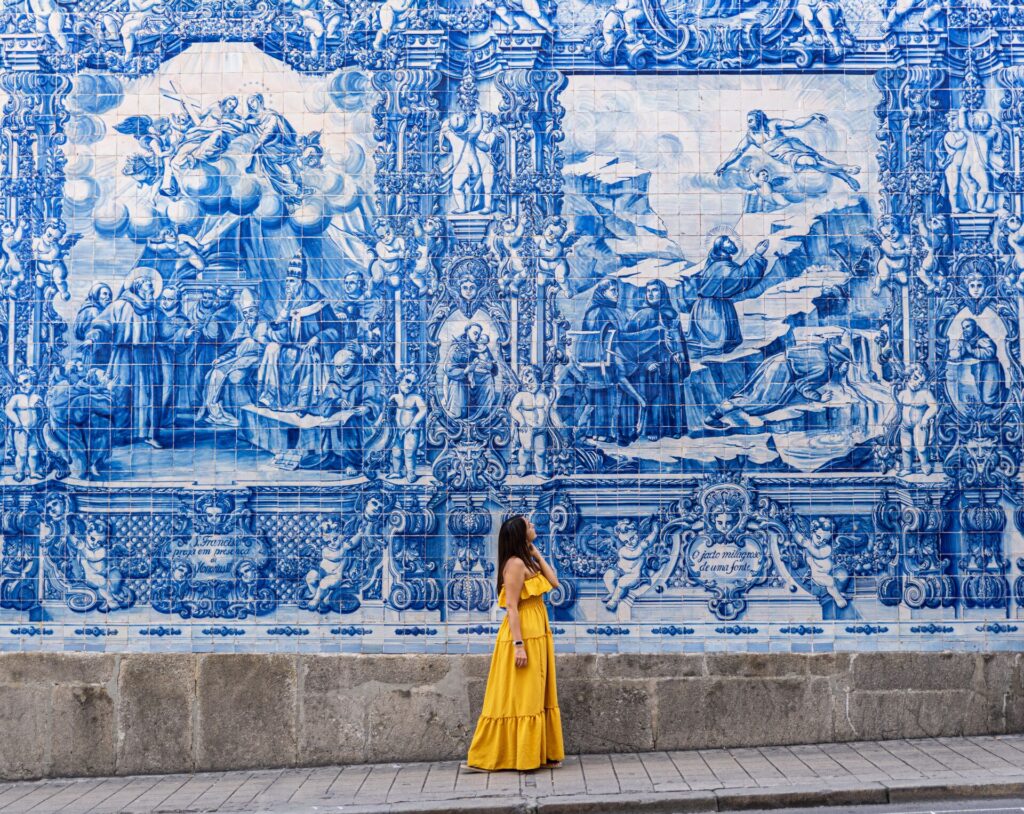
[686,234,768,359]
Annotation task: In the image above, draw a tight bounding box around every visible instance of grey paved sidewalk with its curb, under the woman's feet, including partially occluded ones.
[0,735,1024,814]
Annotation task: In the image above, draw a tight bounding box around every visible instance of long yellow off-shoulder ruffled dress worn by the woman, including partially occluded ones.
[466,573,565,771]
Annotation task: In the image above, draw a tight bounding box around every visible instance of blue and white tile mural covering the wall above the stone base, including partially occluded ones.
[0,0,1024,652]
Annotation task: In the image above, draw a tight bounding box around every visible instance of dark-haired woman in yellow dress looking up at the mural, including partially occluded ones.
[466,515,564,771]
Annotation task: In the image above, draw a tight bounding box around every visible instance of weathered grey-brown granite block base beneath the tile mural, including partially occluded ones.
[0,652,1024,779]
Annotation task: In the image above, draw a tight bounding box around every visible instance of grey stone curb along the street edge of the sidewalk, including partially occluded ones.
[254,778,1024,814]
